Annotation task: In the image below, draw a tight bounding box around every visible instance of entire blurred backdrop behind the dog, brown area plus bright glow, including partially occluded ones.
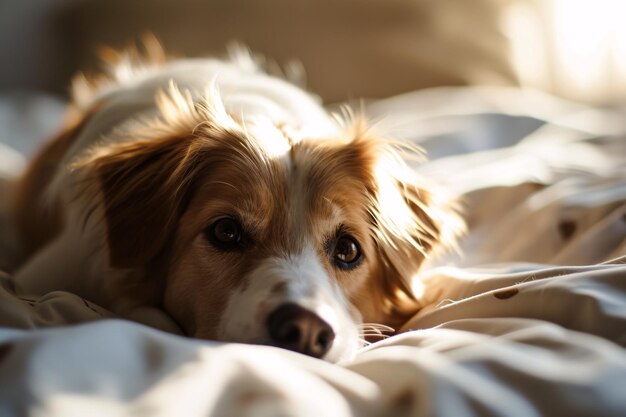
[0,0,626,103]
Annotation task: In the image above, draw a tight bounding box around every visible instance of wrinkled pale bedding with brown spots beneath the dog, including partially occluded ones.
[0,88,626,417]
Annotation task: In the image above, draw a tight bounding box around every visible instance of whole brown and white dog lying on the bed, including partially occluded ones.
[11,42,462,361]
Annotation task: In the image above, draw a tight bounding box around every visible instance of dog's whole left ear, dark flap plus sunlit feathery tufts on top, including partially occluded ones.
[75,83,242,268]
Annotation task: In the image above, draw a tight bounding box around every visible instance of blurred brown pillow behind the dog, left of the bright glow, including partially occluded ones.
[64,0,516,103]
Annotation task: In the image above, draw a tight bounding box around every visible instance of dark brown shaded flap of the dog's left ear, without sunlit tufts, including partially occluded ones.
[81,136,197,268]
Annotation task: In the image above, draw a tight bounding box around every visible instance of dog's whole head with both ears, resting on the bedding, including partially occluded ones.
[73,53,460,360]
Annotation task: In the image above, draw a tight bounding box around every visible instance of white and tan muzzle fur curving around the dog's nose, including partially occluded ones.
[219,246,358,360]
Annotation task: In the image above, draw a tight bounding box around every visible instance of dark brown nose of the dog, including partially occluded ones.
[267,303,335,358]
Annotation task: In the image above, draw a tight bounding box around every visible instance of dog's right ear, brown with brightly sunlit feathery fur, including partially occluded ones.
[352,130,465,327]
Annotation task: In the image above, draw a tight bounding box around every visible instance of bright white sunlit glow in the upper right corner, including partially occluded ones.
[502,0,626,104]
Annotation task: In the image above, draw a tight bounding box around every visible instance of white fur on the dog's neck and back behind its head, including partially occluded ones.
[65,59,338,166]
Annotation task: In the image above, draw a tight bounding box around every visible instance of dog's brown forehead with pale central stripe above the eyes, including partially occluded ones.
[189,131,365,235]
